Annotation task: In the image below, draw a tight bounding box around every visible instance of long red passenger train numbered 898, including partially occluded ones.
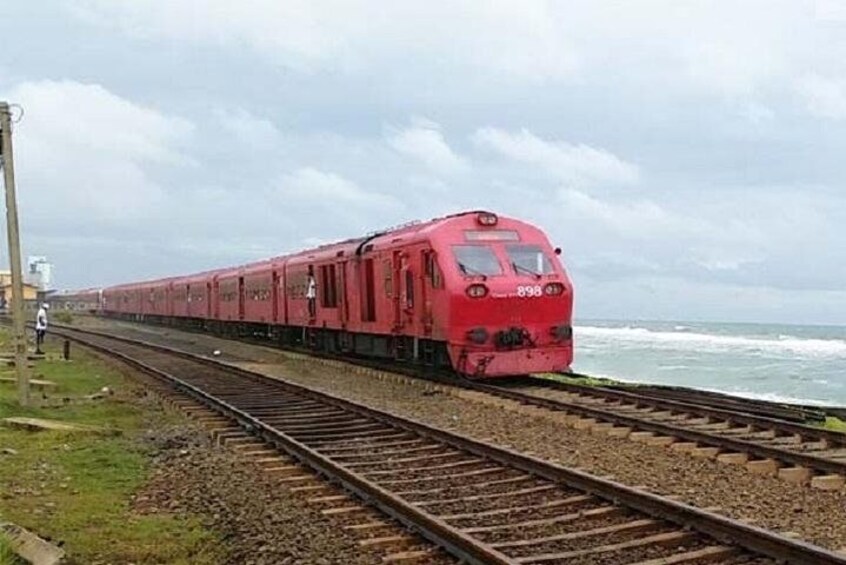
[66,212,573,377]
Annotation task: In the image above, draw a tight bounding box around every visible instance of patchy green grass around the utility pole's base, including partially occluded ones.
[0,330,222,563]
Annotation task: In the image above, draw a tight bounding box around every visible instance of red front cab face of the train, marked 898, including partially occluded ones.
[432,212,573,377]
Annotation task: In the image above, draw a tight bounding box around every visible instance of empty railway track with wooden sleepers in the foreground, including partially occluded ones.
[46,329,846,565]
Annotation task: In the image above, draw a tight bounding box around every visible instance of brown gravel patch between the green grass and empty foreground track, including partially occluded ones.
[134,426,388,564]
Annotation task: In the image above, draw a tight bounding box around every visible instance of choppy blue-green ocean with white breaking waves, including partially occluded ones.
[573,320,846,406]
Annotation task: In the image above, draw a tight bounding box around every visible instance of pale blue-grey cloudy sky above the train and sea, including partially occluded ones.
[0,0,846,323]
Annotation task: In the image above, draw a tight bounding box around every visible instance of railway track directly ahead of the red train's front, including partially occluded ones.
[476,377,846,490]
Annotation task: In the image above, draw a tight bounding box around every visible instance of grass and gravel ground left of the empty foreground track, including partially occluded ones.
[0,329,384,563]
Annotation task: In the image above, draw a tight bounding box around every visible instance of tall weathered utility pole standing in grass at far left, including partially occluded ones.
[0,102,30,406]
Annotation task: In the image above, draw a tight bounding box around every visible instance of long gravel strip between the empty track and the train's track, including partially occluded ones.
[71,321,846,549]
